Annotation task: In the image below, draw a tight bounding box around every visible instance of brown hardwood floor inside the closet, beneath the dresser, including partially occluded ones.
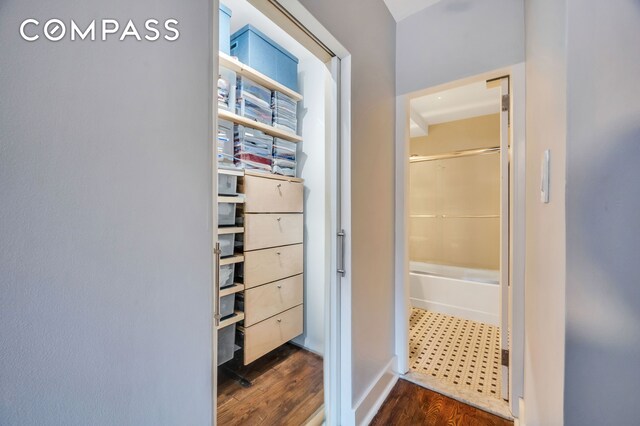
[218,344,324,426]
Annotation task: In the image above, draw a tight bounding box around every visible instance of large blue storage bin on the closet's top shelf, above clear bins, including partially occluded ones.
[231,25,298,91]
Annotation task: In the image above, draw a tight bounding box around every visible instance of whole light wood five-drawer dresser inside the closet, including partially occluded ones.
[239,171,304,365]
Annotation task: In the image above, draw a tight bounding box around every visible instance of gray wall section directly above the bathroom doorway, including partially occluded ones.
[396,0,524,95]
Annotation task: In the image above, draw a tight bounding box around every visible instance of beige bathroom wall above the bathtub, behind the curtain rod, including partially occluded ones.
[409,114,500,269]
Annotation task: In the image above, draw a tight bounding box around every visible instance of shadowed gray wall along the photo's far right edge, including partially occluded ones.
[564,0,640,425]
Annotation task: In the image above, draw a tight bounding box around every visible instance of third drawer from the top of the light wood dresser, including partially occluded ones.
[243,244,304,289]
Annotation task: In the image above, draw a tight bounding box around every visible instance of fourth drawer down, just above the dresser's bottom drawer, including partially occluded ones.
[244,275,303,326]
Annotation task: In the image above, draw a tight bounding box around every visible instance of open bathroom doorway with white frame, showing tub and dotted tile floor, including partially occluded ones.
[396,67,523,418]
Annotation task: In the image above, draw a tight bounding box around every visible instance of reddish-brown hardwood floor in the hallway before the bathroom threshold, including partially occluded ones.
[371,379,513,426]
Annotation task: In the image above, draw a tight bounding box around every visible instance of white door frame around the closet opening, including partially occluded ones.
[209,0,353,426]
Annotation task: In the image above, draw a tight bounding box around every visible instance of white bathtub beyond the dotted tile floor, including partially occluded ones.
[409,262,500,326]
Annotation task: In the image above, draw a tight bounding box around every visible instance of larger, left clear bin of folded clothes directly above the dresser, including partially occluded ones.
[234,125,273,173]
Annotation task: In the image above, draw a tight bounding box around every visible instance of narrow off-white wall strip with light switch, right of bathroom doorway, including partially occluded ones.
[524,0,568,426]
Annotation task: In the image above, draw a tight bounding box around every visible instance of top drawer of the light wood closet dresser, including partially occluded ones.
[244,176,304,213]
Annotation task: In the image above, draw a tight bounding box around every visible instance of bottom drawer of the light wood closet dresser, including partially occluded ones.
[244,305,303,365]
